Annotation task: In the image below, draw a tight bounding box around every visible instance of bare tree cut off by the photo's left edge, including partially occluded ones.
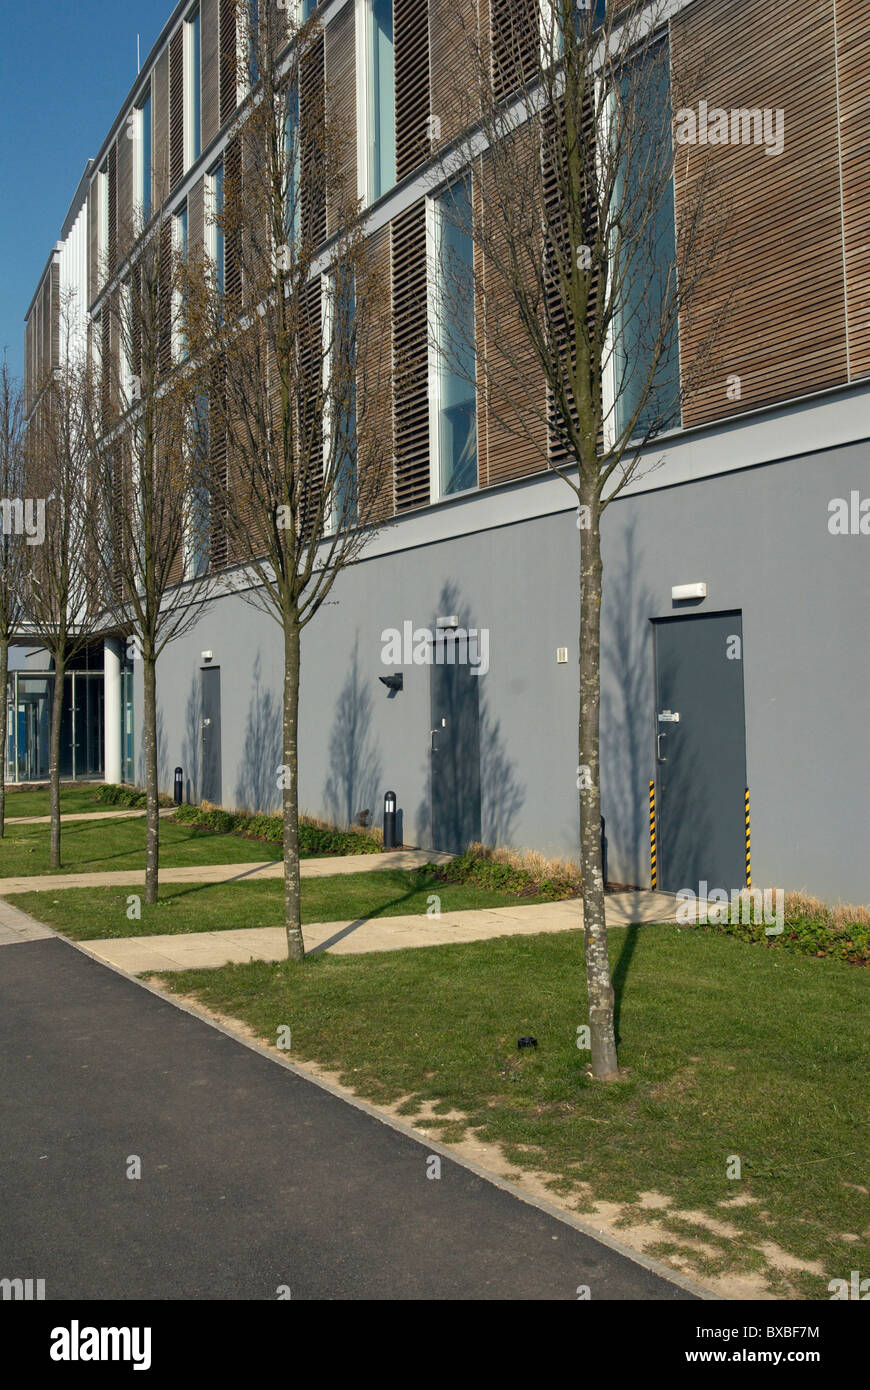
[0,354,28,840]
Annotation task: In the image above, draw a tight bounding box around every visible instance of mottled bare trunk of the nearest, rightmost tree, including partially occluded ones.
[578,496,618,1081]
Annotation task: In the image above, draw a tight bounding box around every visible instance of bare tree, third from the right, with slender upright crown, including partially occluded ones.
[85,218,213,904]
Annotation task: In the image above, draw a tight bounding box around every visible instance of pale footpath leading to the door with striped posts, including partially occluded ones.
[0,892,675,974]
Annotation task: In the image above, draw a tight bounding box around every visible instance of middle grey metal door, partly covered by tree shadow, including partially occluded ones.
[429,638,481,855]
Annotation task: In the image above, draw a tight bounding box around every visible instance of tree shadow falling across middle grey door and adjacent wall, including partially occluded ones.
[417,580,525,849]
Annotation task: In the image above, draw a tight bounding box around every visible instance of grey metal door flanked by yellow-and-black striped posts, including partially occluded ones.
[653,612,746,892]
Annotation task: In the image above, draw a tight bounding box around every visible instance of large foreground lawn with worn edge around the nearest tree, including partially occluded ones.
[152,926,870,1298]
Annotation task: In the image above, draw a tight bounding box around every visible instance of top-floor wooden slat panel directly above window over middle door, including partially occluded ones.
[429,0,478,146]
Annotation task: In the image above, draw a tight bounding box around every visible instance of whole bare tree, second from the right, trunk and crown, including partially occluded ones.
[185,4,391,962]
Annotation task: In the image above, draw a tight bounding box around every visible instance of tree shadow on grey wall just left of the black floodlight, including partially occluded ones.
[324,632,384,826]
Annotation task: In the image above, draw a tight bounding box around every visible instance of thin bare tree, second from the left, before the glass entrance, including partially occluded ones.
[22,297,99,869]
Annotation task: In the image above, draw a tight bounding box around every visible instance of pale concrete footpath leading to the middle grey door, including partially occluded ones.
[0,849,453,898]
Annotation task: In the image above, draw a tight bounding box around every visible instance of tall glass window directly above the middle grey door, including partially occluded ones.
[432,179,477,496]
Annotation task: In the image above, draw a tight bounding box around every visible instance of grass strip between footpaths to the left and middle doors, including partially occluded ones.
[0,816,281,878]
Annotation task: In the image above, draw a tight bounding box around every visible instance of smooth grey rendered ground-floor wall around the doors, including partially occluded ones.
[142,445,870,902]
